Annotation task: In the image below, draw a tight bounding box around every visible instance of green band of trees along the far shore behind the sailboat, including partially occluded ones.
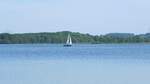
[0,31,150,44]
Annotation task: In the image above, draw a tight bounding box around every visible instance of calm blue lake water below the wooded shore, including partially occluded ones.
[0,44,150,84]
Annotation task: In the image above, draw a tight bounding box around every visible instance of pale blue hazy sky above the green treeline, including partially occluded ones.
[0,0,150,34]
